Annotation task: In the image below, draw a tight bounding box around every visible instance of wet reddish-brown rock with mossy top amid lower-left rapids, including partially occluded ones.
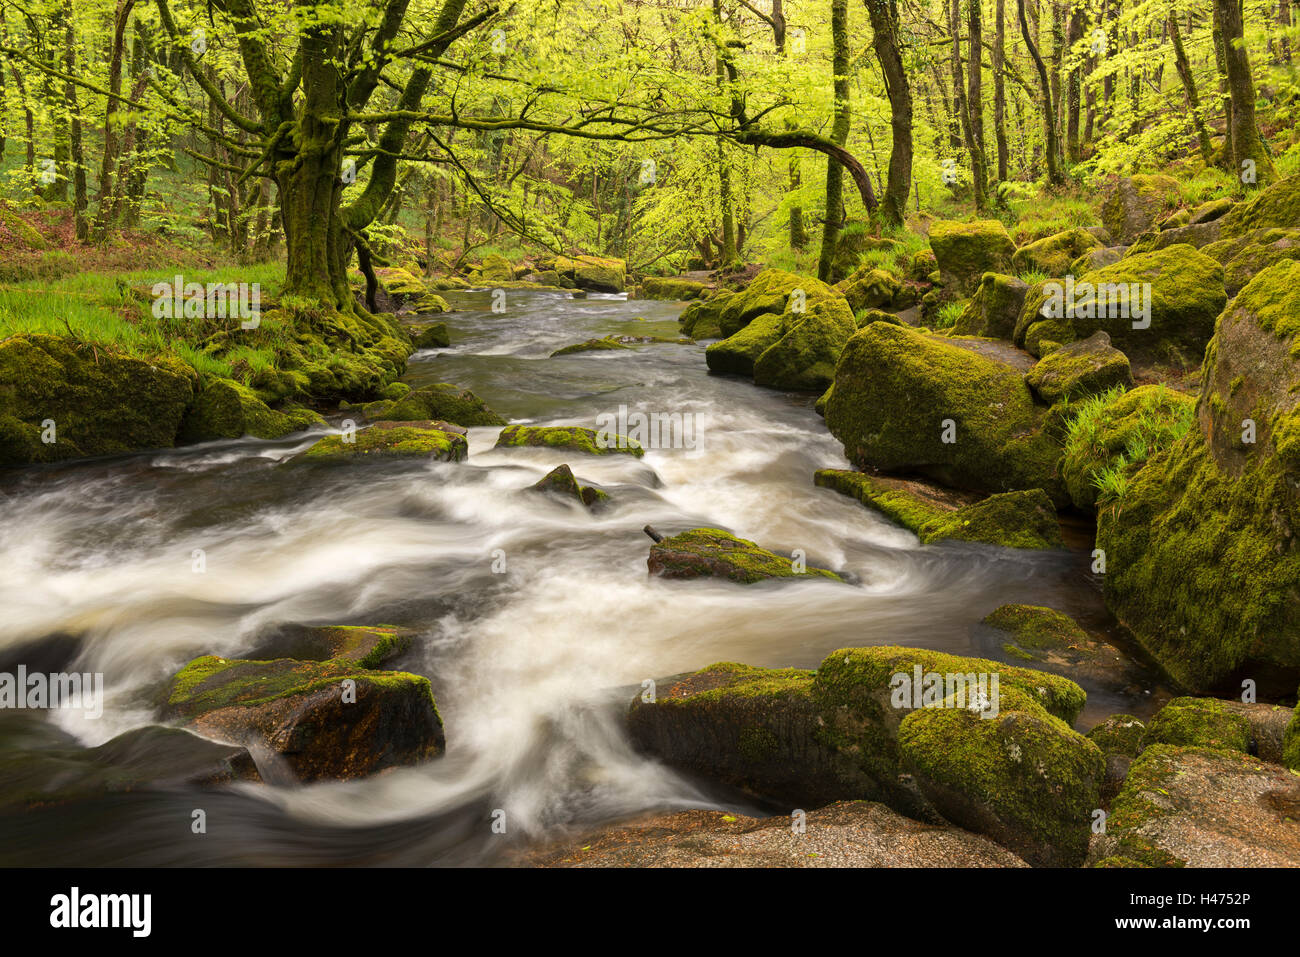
[163,655,443,781]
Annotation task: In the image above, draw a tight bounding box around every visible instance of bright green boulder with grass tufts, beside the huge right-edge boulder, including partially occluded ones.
[1049,382,1196,512]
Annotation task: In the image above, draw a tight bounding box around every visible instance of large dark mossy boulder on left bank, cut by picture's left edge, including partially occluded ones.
[0,333,199,467]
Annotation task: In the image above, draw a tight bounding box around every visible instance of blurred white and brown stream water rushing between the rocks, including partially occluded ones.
[0,293,1151,865]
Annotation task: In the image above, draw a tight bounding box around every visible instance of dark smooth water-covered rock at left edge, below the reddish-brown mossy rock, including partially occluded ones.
[0,716,261,810]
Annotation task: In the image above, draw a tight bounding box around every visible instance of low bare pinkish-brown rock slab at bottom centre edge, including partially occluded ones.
[516,801,1026,867]
